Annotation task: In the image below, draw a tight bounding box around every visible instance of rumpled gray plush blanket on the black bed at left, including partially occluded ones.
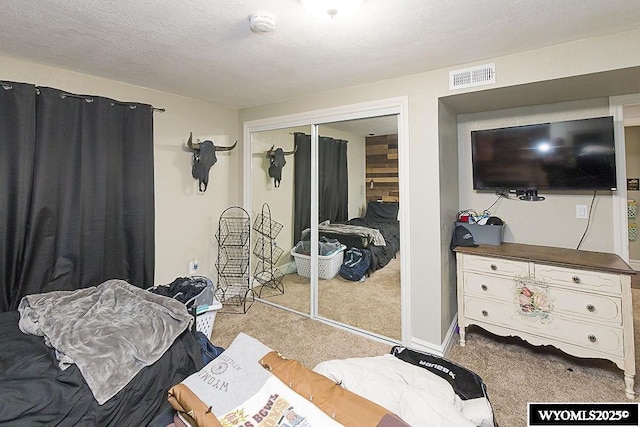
[18,280,192,405]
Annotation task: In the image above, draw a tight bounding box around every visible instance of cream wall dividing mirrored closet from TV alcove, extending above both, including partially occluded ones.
[240,26,640,346]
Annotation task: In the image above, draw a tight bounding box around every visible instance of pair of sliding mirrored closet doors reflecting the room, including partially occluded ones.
[245,98,409,342]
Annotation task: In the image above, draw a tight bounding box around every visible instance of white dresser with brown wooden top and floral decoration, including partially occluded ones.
[455,243,635,399]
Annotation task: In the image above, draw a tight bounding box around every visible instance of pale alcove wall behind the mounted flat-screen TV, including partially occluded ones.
[458,98,614,252]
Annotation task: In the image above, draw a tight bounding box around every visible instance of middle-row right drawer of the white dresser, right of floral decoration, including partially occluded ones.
[549,288,622,324]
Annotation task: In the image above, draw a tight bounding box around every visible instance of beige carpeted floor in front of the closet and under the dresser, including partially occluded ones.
[212,289,640,427]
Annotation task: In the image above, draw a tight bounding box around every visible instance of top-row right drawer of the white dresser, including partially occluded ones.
[534,264,621,295]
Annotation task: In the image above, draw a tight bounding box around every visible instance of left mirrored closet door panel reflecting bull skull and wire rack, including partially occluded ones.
[251,126,311,314]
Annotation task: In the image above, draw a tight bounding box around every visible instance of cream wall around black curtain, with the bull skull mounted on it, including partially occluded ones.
[0,57,240,286]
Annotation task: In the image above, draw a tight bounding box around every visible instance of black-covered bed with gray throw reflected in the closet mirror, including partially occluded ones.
[302,201,400,273]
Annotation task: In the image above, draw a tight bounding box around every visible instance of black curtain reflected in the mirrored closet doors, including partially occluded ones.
[293,132,349,241]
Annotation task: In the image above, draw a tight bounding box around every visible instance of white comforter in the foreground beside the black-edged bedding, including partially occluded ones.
[314,354,493,427]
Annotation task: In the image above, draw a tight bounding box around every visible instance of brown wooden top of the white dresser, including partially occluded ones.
[454,243,636,274]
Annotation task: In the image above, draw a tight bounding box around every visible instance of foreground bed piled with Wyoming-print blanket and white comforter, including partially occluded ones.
[169,333,495,427]
